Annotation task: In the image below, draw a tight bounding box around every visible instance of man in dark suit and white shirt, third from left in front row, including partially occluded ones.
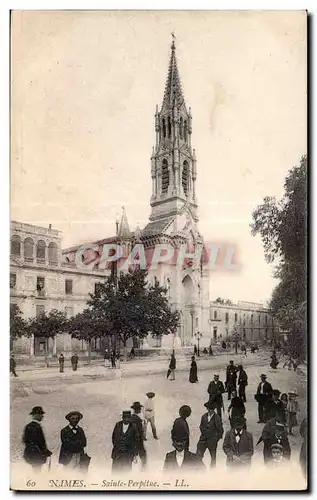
[111,411,140,473]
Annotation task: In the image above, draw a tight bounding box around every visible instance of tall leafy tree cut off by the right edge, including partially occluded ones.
[251,156,307,356]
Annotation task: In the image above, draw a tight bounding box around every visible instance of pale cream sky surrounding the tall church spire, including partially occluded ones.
[11,11,307,303]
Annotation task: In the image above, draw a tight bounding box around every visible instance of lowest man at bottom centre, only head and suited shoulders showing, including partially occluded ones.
[163,439,205,472]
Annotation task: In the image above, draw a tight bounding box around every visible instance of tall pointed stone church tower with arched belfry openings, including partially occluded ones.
[150,41,198,226]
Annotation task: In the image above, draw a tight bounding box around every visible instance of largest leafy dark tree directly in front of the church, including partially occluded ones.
[87,268,178,359]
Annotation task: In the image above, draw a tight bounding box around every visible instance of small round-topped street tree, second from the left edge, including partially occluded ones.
[27,309,68,366]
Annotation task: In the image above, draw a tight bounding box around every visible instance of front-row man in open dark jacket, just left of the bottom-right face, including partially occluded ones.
[222,417,254,467]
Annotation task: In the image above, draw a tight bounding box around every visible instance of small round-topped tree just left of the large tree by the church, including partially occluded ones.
[67,309,110,363]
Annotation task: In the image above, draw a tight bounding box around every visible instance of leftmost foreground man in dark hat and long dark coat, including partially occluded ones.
[22,406,52,472]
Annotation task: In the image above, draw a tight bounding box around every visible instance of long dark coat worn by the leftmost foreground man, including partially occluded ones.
[22,421,52,465]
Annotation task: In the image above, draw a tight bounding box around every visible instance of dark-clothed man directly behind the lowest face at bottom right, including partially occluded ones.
[257,418,291,463]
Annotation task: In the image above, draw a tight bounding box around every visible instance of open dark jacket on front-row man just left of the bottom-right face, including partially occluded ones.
[222,429,254,466]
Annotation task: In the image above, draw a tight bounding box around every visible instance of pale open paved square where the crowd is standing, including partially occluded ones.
[11,353,306,492]
